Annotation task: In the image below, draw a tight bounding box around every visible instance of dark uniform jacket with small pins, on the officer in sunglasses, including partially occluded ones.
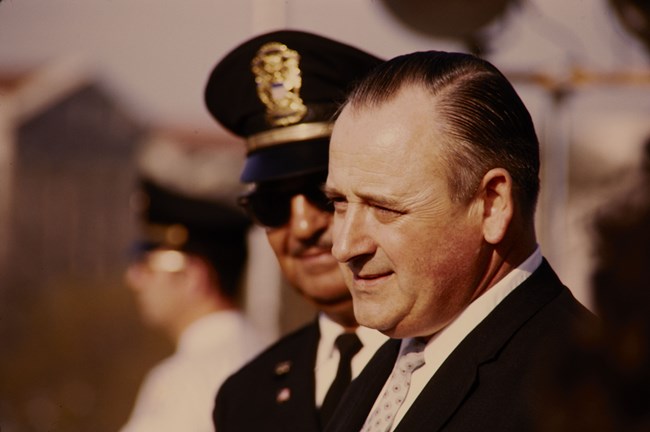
[213,321,321,432]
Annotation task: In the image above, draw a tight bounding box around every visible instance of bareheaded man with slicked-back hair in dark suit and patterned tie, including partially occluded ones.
[325,51,592,432]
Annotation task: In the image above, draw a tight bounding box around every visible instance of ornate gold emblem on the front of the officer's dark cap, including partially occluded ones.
[251,42,307,126]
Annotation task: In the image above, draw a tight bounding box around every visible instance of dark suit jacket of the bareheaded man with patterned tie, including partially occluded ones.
[326,260,594,432]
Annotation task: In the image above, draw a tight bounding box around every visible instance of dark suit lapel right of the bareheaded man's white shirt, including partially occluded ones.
[395,260,563,432]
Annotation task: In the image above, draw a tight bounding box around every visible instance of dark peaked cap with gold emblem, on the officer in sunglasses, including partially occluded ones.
[205,30,382,183]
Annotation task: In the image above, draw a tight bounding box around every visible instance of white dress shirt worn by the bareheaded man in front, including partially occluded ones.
[370,246,542,431]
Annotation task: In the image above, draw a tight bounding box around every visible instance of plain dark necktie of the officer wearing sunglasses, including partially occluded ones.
[320,332,363,427]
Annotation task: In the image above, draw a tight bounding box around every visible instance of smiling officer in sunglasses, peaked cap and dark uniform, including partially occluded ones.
[205,31,386,432]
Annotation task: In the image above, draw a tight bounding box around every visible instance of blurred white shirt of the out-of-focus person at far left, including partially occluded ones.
[121,311,264,432]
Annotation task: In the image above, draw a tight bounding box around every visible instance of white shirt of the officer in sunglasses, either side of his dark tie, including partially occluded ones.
[314,313,388,407]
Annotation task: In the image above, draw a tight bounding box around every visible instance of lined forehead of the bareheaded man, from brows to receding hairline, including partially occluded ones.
[328,87,446,186]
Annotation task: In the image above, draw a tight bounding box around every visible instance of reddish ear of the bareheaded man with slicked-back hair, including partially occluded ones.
[479,168,514,245]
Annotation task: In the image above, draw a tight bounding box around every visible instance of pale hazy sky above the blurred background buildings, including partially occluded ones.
[0,0,648,132]
